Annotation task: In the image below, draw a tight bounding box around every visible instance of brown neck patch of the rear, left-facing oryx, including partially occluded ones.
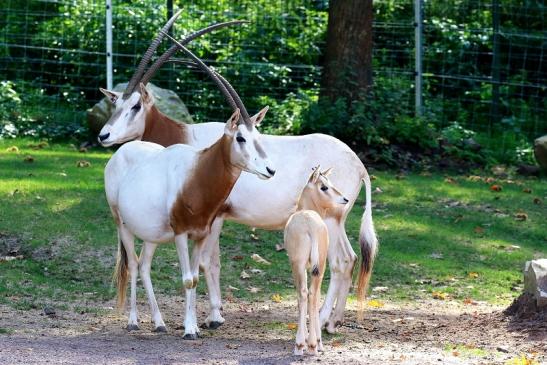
[141,105,188,147]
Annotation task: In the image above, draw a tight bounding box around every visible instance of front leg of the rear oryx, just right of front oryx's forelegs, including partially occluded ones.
[200,218,224,329]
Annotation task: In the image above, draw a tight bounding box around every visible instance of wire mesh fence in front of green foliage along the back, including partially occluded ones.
[0,0,547,142]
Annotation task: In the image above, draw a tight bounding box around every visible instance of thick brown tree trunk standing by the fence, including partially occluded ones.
[320,0,373,102]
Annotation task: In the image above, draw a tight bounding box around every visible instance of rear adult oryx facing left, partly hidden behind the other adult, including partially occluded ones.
[99,13,377,333]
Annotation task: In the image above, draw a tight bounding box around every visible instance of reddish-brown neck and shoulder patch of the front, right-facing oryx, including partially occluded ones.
[171,135,241,237]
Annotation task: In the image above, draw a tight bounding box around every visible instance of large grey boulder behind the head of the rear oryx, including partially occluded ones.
[87,83,194,135]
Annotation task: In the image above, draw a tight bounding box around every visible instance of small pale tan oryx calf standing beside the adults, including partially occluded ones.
[285,166,348,355]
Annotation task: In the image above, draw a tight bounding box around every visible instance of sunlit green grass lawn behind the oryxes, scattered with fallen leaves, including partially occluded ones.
[0,139,547,309]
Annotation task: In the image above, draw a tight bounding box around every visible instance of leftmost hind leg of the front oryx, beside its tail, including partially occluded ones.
[118,224,139,331]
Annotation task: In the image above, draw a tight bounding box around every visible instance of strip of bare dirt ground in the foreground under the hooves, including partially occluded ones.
[0,297,547,365]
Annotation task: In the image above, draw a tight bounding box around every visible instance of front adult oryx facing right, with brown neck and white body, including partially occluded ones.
[105,55,275,339]
